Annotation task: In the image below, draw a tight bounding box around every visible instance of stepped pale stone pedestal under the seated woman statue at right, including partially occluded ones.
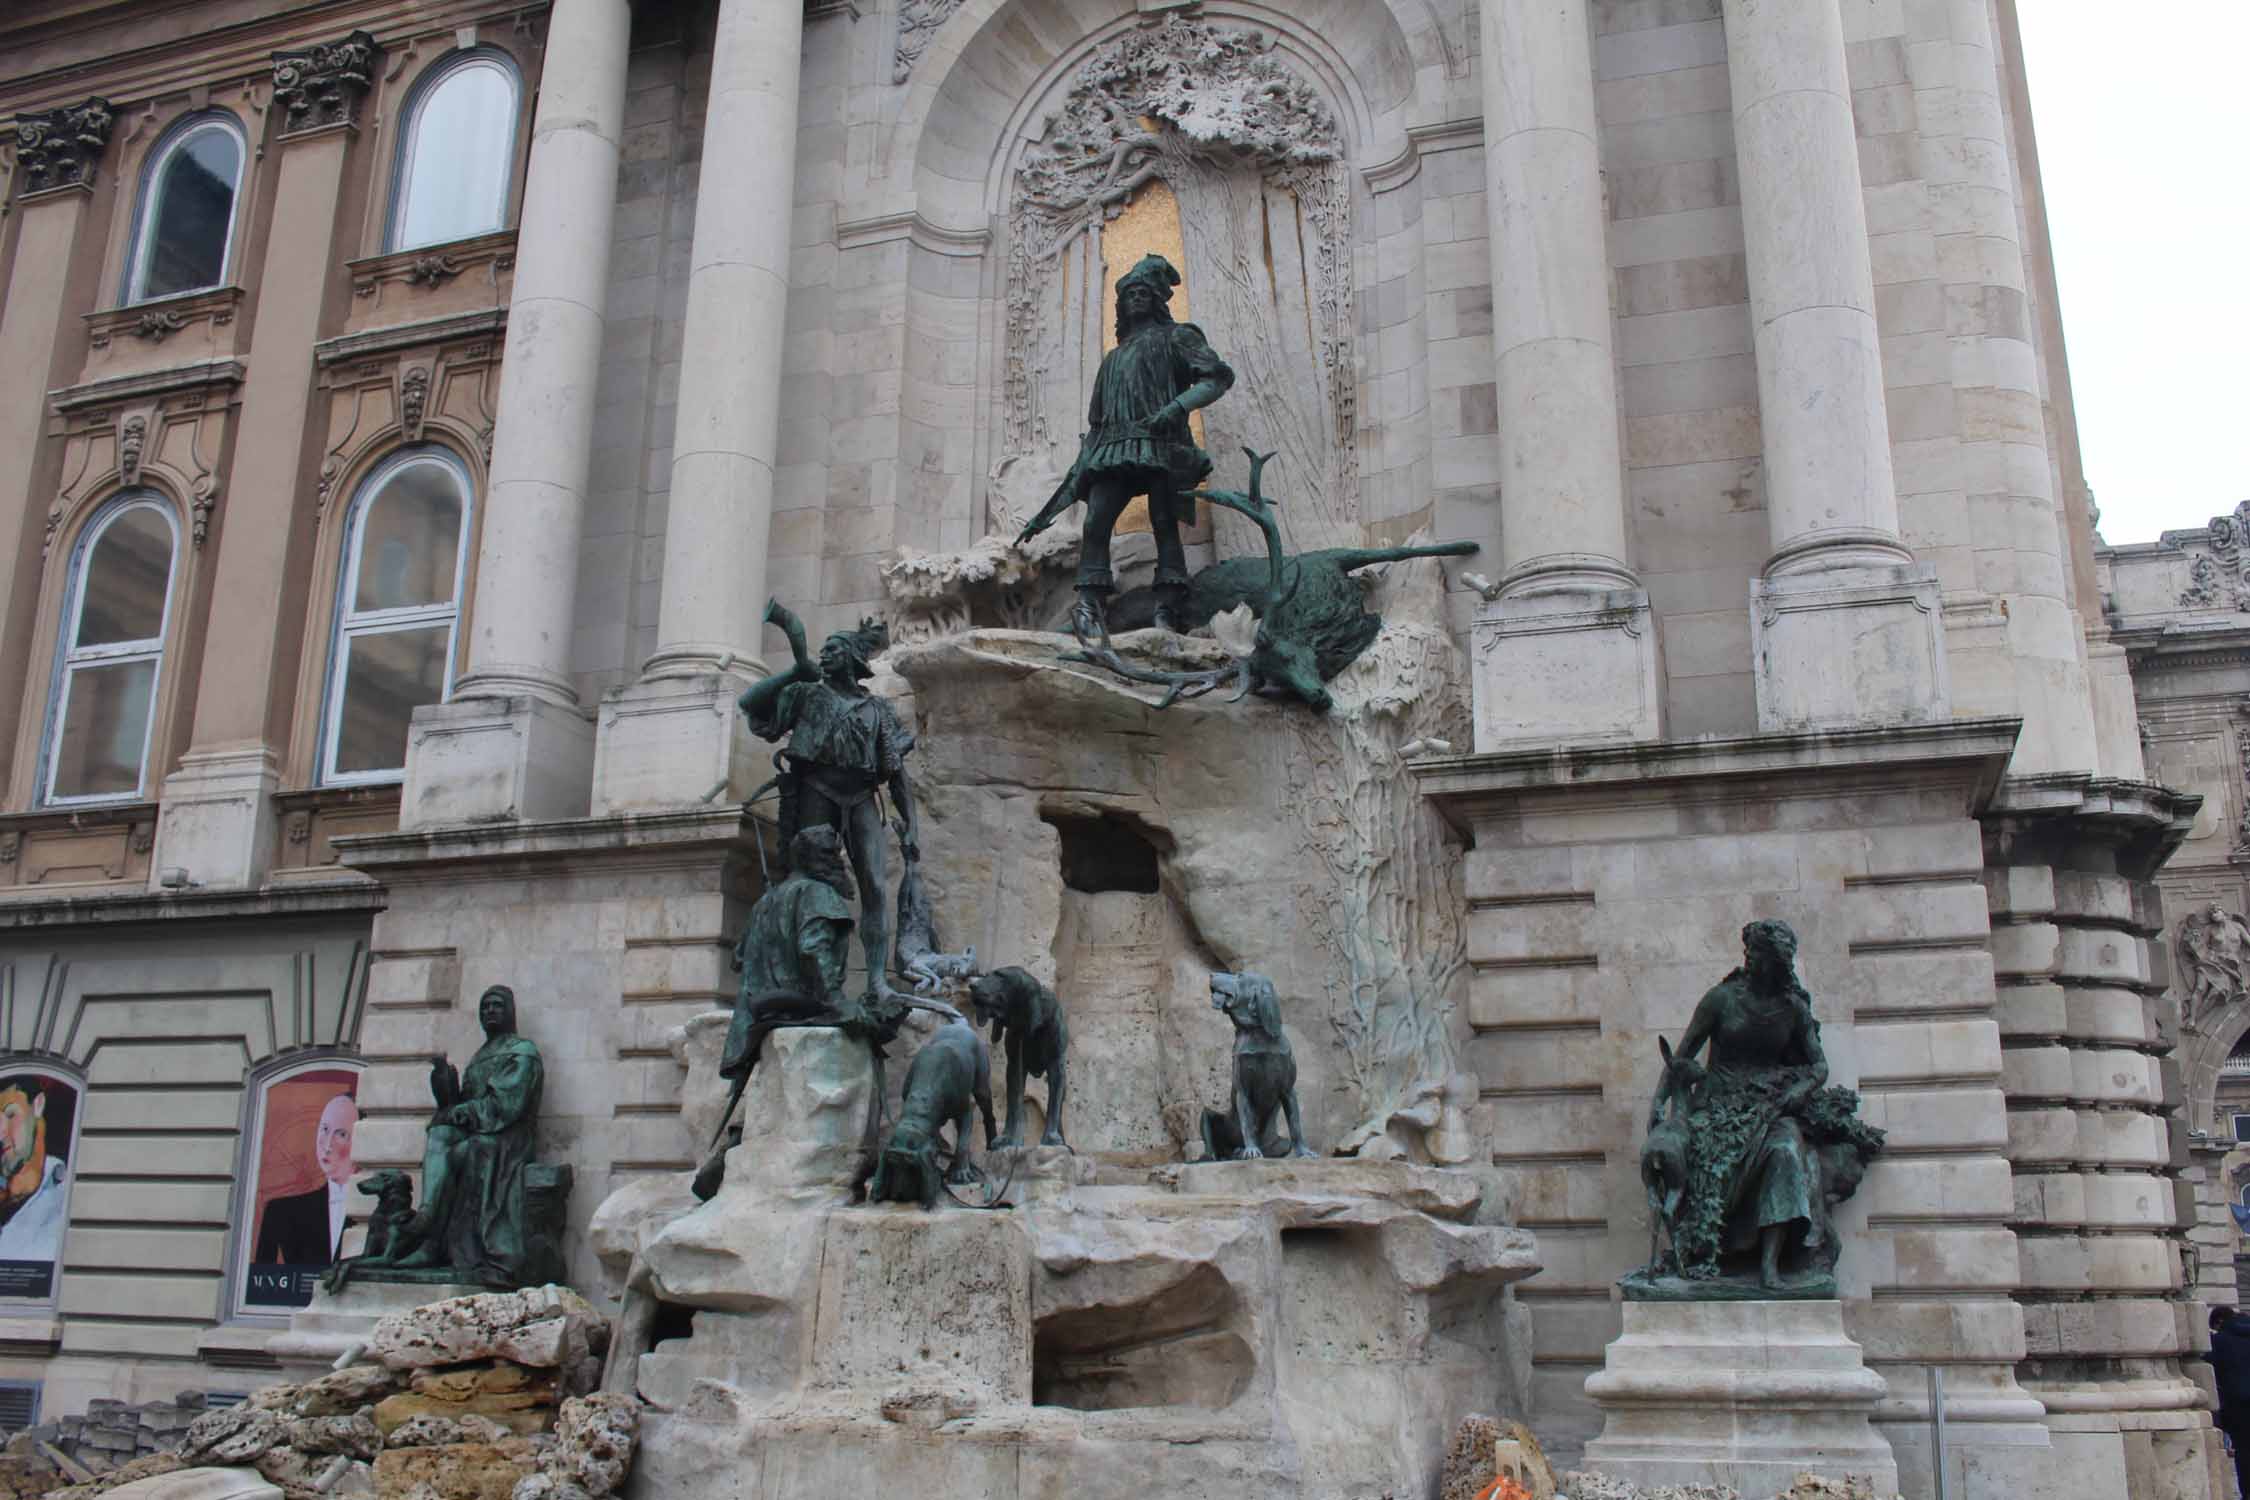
[1586,1302,1899,1500]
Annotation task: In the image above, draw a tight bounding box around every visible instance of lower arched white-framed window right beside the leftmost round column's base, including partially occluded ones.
[322,448,470,785]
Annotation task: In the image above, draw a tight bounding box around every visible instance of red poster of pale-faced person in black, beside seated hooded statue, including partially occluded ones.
[241,1068,360,1311]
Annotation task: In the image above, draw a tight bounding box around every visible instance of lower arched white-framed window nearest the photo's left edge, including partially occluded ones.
[45,495,178,803]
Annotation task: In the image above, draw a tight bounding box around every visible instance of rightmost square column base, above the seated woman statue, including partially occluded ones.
[1751,562,1953,733]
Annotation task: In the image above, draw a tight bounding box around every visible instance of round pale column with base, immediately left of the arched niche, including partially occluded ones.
[594,0,806,812]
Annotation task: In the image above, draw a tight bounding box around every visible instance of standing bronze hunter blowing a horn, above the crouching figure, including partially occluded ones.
[738,600,920,992]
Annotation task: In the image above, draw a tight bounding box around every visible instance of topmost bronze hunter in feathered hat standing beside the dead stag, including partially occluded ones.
[1017,254,1235,639]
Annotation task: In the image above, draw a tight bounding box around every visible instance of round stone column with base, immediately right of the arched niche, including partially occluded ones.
[1476,0,1661,751]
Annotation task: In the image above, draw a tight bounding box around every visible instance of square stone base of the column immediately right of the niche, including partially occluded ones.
[1472,589,1663,753]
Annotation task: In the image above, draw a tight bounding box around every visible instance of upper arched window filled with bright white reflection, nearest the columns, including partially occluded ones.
[389,52,522,250]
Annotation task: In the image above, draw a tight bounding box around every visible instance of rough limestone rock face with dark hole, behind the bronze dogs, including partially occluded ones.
[891,550,1478,1165]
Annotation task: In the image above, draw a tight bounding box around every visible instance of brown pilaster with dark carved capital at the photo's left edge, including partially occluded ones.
[0,99,115,807]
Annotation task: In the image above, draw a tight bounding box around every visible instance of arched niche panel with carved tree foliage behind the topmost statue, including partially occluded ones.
[999,16,1359,546]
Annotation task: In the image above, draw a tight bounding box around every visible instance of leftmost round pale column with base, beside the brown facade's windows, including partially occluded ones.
[401,0,632,828]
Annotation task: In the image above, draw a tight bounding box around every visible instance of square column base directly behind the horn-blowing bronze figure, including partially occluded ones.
[594,672,772,816]
